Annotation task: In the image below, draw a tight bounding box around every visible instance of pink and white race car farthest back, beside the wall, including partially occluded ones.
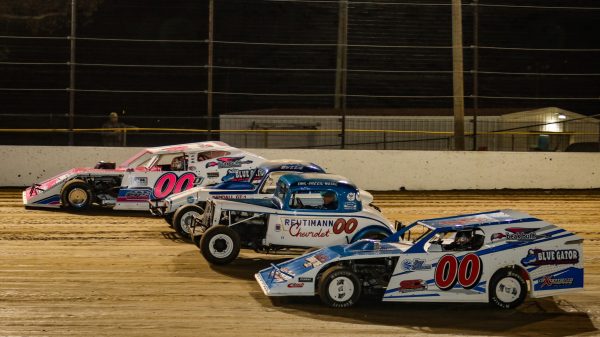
[23,142,265,210]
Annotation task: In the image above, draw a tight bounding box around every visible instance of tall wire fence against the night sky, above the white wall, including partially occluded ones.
[0,0,600,151]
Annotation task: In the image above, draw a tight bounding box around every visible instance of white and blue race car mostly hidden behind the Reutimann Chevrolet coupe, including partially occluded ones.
[149,159,325,237]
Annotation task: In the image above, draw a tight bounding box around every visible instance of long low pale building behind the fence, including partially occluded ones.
[220,107,599,151]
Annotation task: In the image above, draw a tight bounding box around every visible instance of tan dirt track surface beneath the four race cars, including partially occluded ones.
[0,189,600,337]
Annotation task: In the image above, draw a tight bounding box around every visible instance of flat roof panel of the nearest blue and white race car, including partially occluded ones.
[418,209,542,230]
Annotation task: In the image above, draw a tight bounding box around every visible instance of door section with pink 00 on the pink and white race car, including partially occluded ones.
[114,153,202,210]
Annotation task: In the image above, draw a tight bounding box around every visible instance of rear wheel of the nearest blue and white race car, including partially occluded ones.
[489,269,527,309]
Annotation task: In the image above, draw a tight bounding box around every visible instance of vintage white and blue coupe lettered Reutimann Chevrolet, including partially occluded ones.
[192,173,393,264]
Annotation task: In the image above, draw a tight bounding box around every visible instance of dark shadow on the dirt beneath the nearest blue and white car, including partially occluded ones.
[251,292,597,337]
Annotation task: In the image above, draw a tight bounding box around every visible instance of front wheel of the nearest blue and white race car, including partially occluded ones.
[318,267,361,308]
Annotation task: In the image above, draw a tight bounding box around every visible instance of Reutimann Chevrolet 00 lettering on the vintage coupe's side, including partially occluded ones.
[281,218,358,238]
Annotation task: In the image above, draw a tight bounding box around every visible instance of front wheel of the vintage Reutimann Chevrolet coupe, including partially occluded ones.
[200,225,240,265]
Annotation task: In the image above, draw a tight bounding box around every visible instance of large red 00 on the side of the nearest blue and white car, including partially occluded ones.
[435,254,482,290]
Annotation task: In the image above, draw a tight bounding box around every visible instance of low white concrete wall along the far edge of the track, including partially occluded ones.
[0,146,600,190]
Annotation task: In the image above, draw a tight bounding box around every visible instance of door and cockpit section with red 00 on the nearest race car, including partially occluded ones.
[383,228,488,302]
